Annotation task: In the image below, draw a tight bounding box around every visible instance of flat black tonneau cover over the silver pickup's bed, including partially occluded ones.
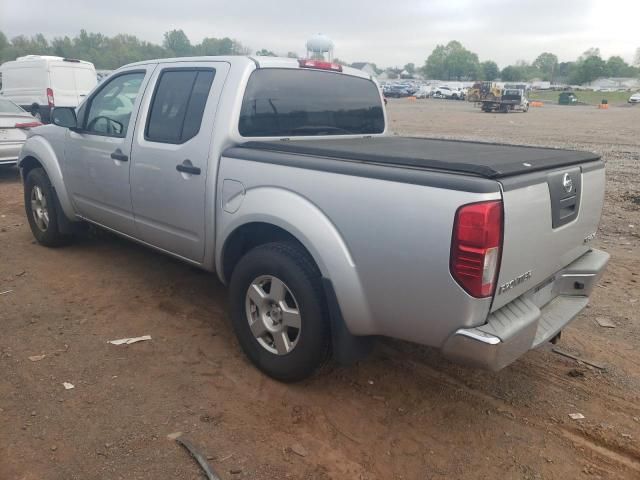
[240,136,600,179]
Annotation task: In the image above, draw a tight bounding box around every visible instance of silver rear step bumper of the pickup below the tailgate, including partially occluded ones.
[442,250,609,371]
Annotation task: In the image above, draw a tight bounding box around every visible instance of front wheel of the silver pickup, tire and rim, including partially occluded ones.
[24,168,72,247]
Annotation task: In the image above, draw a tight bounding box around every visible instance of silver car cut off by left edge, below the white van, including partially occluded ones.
[0,97,42,166]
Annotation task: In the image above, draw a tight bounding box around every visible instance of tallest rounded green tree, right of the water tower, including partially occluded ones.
[423,40,479,80]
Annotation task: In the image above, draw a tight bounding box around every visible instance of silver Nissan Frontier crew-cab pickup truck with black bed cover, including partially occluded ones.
[19,57,608,381]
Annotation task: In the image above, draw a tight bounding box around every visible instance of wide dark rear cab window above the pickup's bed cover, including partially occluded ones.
[238,68,384,137]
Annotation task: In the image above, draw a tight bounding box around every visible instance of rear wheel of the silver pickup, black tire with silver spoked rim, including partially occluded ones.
[229,243,331,382]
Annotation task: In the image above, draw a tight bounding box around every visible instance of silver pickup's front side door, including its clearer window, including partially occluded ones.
[63,67,152,235]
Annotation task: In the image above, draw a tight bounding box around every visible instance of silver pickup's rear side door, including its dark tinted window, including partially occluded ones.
[131,62,229,262]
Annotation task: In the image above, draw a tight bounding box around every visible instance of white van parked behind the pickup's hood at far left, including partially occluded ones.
[0,55,97,123]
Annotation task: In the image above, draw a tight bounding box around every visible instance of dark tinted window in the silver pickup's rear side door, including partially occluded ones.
[145,69,215,143]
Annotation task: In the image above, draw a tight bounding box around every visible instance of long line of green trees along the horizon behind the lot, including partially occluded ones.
[0,30,640,84]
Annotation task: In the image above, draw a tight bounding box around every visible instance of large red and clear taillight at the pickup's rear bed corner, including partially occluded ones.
[450,200,502,298]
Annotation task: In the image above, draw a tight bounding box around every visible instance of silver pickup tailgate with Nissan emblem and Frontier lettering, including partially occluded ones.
[491,160,605,311]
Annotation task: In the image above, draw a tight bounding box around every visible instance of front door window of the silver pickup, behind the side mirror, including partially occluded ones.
[84,72,145,137]
